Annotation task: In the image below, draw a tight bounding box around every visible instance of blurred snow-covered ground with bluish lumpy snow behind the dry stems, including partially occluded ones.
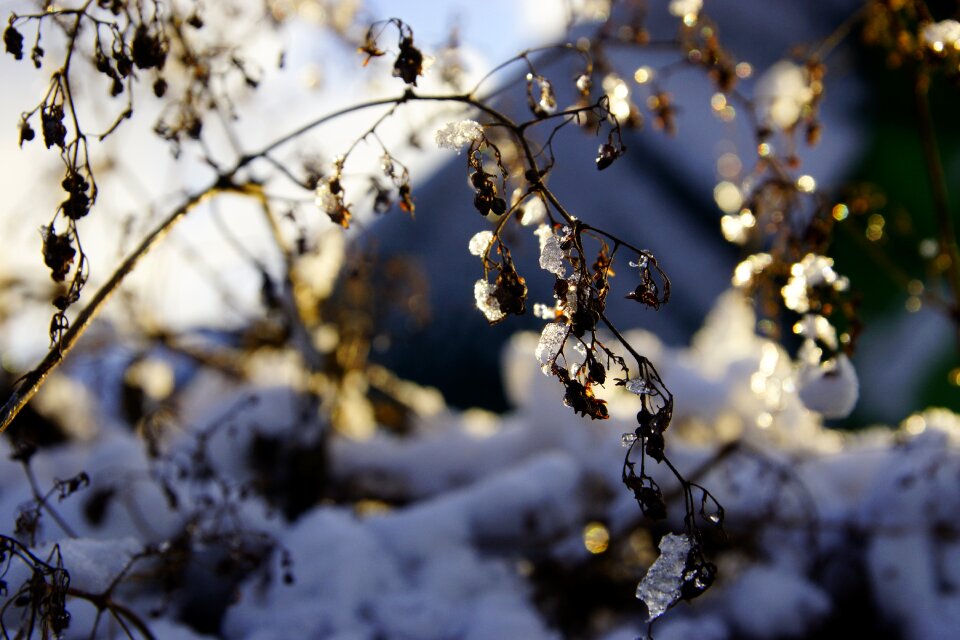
[0,292,960,640]
